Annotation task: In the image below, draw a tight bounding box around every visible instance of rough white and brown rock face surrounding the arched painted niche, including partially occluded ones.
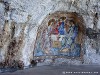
[0,0,100,66]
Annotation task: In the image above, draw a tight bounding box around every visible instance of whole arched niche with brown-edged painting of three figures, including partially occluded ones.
[34,11,85,60]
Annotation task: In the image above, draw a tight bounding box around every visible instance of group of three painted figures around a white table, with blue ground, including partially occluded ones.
[34,17,81,57]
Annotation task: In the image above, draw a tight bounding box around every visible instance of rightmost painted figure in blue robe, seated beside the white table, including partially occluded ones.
[66,20,78,48]
